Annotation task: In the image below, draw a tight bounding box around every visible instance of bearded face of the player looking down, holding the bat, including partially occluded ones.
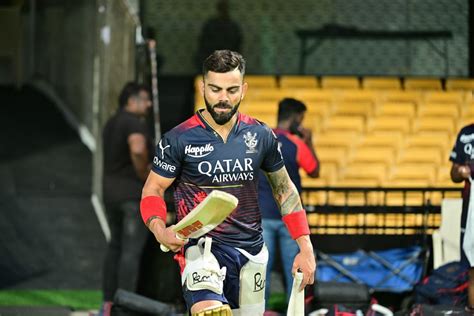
[201,69,247,125]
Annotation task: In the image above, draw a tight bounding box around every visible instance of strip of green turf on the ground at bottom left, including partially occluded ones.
[0,290,102,310]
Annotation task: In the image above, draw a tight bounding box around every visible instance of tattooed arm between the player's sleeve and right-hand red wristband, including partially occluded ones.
[267,167,303,215]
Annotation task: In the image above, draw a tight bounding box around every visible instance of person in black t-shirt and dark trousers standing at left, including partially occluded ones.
[101,82,154,315]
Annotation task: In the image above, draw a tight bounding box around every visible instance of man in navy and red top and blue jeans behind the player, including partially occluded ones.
[258,98,320,310]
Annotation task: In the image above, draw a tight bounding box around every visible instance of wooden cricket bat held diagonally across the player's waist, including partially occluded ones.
[160,190,239,252]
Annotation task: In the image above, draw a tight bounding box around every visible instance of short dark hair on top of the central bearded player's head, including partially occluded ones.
[202,49,245,76]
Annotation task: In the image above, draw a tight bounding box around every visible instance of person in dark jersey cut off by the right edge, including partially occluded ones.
[449,124,474,315]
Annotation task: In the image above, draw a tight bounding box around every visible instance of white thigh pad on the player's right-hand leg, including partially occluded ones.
[237,245,268,315]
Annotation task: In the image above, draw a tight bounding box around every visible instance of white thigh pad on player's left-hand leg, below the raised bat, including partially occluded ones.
[181,237,227,294]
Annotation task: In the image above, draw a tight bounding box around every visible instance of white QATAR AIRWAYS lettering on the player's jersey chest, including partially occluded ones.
[198,158,254,183]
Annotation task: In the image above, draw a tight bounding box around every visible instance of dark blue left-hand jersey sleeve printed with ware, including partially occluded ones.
[152,133,183,178]
